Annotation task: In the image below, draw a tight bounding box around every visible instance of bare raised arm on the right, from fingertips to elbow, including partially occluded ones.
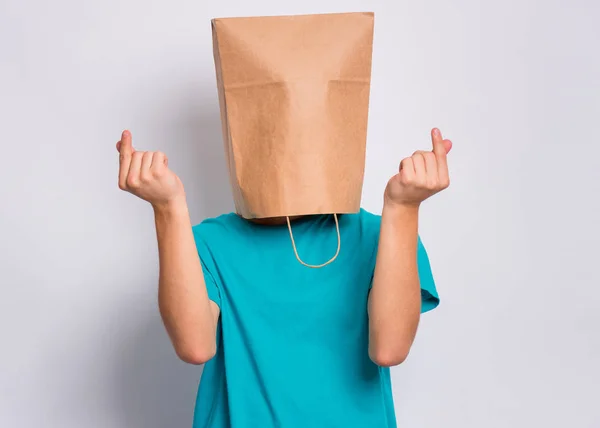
[368,129,452,367]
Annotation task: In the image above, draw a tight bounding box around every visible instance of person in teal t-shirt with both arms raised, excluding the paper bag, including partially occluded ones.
[117,124,452,428]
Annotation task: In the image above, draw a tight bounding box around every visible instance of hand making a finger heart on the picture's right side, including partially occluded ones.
[385,128,452,207]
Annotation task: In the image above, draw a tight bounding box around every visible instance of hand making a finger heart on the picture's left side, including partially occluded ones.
[117,131,185,208]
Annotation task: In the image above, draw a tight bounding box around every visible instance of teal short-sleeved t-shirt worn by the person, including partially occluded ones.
[193,210,439,428]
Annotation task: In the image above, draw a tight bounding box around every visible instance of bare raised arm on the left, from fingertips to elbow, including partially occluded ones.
[117,131,219,364]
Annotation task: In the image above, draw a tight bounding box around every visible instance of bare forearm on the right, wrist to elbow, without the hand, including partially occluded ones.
[369,204,421,366]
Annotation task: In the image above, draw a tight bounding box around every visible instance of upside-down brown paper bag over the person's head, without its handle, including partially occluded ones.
[212,13,374,218]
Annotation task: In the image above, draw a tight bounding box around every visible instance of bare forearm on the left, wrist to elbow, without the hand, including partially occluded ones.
[154,200,218,364]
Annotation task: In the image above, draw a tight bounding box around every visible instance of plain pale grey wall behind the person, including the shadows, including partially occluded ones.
[0,0,600,428]
